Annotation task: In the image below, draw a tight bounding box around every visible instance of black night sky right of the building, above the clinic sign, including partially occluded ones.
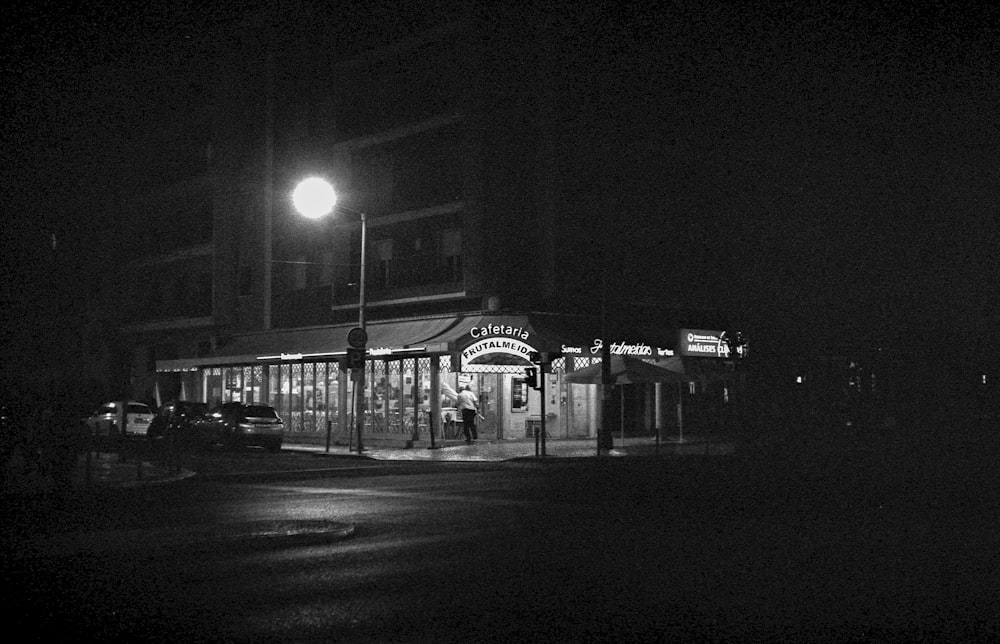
[544,2,1000,352]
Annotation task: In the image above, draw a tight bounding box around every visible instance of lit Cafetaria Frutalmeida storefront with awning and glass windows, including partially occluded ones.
[157,313,748,446]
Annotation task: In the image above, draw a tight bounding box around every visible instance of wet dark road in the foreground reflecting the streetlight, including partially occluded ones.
[3,442,1000,642]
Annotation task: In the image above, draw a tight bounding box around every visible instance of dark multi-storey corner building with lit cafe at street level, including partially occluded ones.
[109,8,737,444]
